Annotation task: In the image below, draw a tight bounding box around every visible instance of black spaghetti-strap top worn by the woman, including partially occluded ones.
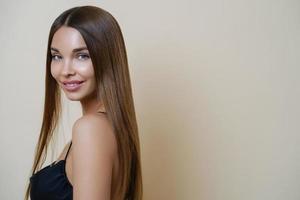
[30,141,73,200]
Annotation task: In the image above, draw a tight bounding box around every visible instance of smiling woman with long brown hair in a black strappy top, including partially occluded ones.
[25,6,142,200]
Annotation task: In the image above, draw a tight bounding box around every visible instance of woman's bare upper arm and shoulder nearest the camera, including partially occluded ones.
[72,114,117,200]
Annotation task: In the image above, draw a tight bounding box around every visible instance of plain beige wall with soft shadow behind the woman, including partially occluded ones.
[0,0,300,200]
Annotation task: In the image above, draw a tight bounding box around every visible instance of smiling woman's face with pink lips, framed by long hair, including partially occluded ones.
[51,26,95,100]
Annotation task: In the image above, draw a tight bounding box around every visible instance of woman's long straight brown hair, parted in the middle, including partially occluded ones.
[25,6,143,200]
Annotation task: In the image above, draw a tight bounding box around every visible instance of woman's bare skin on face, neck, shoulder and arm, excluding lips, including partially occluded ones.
[51,27,119,200]
